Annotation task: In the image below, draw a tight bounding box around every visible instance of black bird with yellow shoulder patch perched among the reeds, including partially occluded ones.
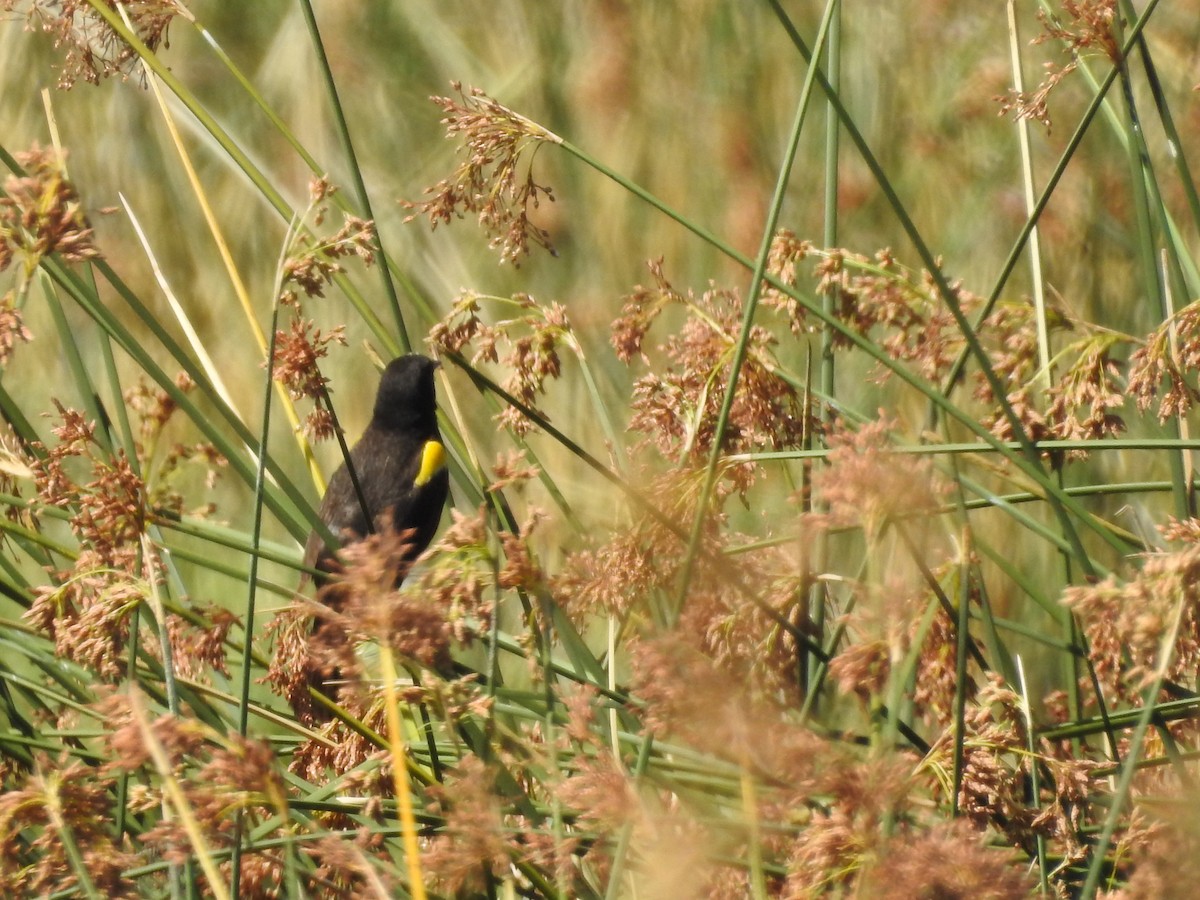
[304,353,450,586]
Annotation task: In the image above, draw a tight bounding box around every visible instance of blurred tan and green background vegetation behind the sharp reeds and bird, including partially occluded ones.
[0,0,1200,897]
